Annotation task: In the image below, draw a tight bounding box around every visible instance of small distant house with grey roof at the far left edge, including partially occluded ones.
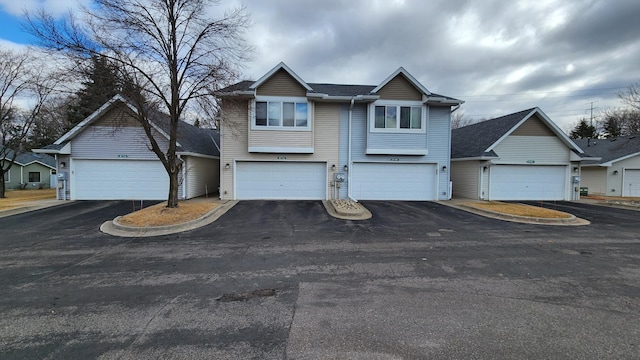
[0,150,56,189]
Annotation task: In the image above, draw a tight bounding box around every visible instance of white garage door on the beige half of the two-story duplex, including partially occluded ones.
[236,161,327,200]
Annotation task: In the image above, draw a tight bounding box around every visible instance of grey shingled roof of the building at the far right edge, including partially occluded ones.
[573,135,640,166]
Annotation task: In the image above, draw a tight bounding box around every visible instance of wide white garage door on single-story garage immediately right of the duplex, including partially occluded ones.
[489,165,567,200]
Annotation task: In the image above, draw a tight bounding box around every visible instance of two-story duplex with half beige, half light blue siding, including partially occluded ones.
[216,63,462,200]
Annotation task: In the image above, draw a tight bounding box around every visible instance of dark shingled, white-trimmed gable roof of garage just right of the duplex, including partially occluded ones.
[451,107,583,159]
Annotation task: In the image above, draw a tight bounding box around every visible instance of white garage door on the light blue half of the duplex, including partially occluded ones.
[350,163,436,201]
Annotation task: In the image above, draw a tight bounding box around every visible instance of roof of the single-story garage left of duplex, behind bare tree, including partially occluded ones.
[34,95,220,157]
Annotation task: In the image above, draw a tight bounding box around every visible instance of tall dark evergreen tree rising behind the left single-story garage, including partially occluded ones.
[67,55,121,130]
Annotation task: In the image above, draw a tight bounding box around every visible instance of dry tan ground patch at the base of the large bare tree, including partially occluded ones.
[118,201,218,227]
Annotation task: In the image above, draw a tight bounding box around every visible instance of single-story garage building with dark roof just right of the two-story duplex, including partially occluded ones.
[451,108,585,200]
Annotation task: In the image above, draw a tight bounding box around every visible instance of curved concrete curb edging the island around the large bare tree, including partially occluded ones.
[100,200,238,237]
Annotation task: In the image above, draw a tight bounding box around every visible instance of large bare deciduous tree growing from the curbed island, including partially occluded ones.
[26,0,251,207]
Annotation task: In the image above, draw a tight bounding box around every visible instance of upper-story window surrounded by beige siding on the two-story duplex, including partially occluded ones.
[253,98,311,130]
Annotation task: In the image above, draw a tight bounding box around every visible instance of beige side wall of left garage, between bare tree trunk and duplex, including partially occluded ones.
[185,156,220,199]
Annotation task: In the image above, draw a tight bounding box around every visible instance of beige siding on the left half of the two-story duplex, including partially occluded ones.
[220,99,340,199]
